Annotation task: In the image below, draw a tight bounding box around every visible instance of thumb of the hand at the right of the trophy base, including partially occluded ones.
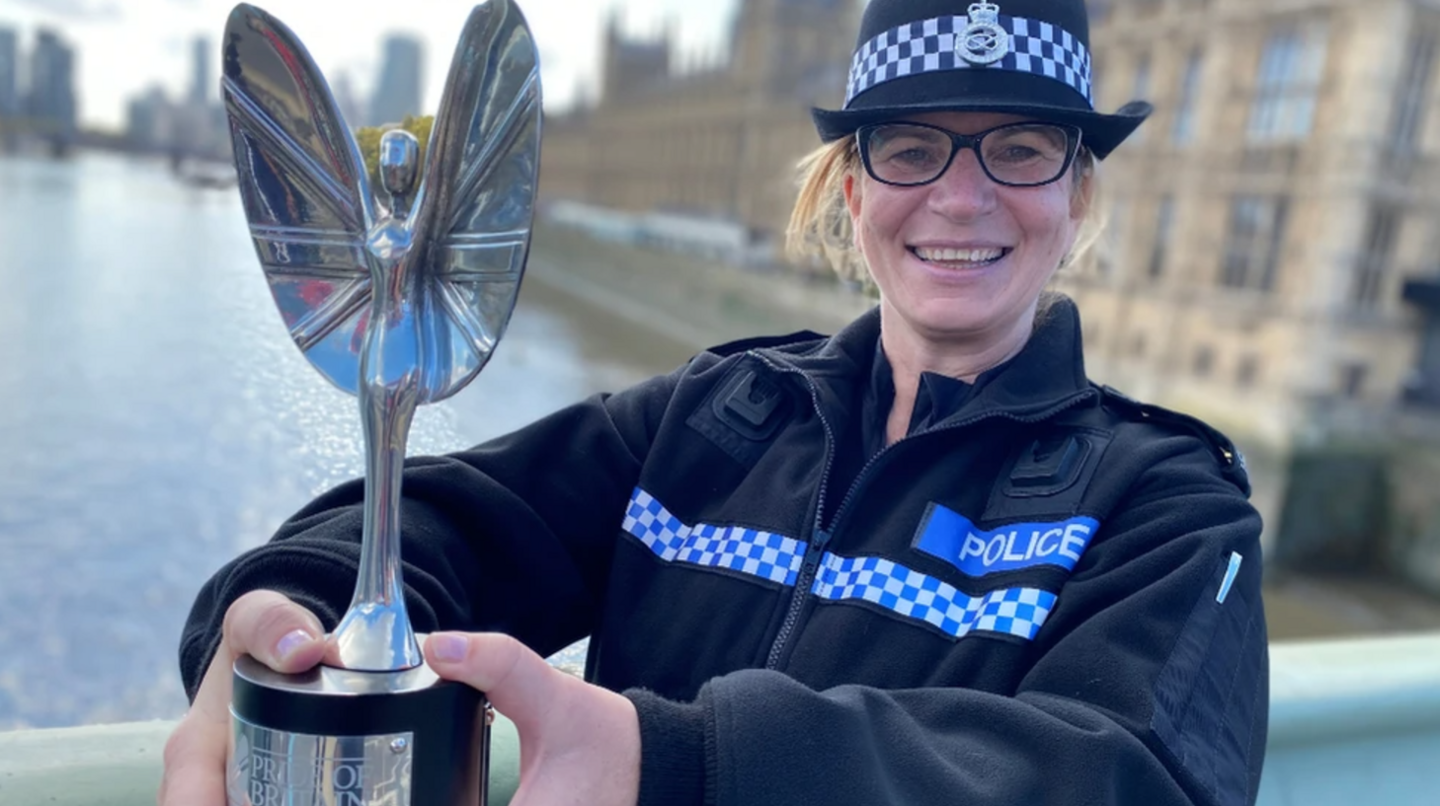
[425,632,564,734]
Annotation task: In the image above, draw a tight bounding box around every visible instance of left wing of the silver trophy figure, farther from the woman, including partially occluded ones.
[222,4,374,394]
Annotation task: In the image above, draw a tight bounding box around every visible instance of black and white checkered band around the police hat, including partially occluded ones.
[845,14,1094,109]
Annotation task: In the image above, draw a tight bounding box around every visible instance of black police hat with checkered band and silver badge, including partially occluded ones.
[811,0,1151,158]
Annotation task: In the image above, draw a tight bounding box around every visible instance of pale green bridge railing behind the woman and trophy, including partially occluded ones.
[0,633,1440,806]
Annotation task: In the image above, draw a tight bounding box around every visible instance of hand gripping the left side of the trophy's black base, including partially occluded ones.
[158,590,325,806]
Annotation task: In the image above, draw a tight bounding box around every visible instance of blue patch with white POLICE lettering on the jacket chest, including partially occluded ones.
[914,504,1100,577]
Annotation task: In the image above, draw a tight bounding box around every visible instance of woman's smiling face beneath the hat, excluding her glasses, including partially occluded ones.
[845,112,1087,360]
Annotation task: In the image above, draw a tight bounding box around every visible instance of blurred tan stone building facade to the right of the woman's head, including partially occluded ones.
[1063,0,1440,449]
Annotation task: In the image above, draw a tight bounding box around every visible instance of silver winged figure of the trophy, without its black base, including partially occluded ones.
[222,0,541,671]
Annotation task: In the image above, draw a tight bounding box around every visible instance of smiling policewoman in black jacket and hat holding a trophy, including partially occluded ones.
[161,0,1267,806]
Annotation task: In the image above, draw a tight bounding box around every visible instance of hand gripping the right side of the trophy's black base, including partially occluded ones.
[425,632,639,806]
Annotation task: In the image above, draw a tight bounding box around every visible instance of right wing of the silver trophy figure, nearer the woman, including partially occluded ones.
[416,0,540,402]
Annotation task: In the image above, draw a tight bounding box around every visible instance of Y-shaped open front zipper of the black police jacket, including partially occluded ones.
[750,353,1094,669]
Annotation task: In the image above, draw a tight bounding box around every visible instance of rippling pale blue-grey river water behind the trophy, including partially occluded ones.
[0,155,685,730]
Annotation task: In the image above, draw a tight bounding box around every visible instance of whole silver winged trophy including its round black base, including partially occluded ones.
[222,0,540,806]
